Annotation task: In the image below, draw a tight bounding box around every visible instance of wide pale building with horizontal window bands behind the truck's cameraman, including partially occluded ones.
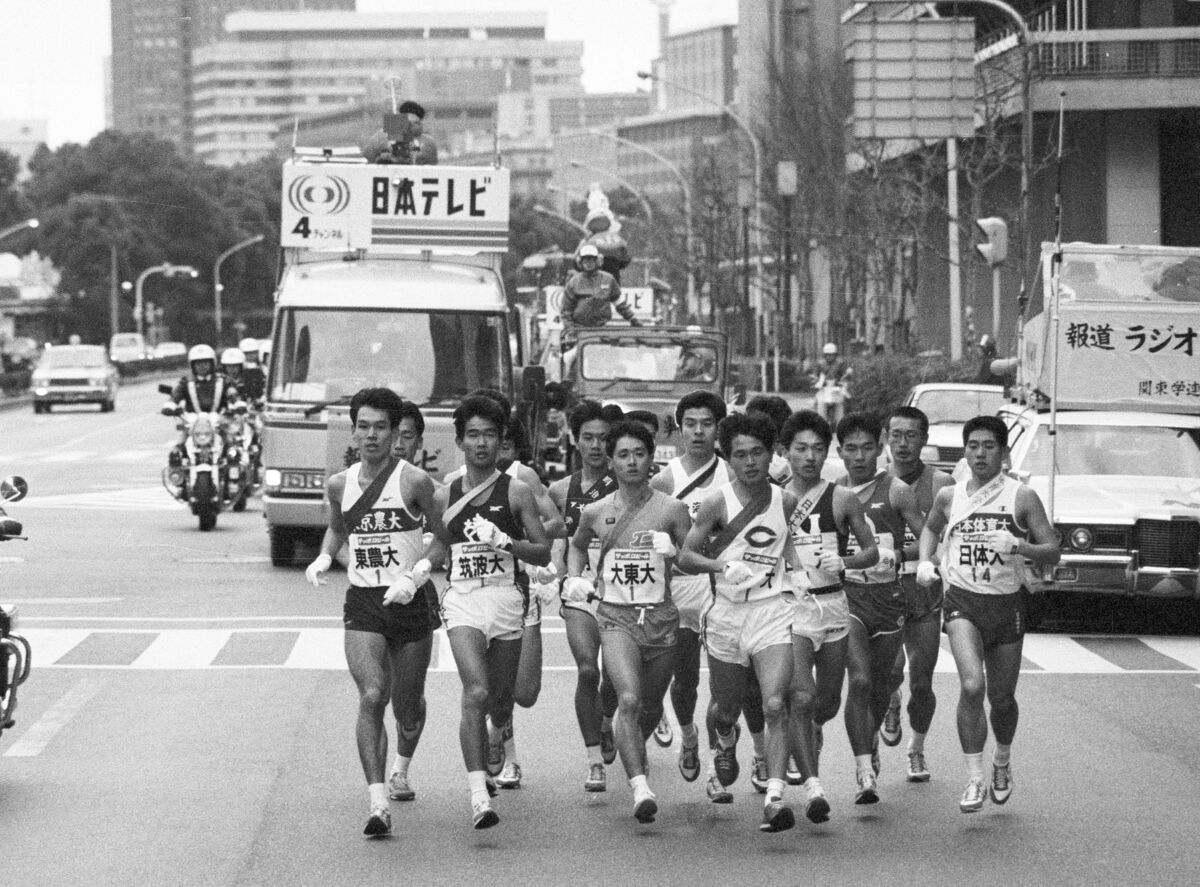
[192,12,583,163]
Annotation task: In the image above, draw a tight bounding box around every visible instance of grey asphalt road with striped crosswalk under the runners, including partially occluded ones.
[0,383,1200,885]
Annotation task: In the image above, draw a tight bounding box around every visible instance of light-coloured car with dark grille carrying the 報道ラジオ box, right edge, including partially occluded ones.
[1000,404,1200,598]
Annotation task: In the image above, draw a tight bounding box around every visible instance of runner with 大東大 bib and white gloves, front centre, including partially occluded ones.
[563,421,690,822]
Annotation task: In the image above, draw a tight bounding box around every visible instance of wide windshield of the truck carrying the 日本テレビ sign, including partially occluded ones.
[270,308,508,406]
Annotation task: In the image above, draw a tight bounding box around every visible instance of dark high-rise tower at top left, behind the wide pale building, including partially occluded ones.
[110,0,355,151]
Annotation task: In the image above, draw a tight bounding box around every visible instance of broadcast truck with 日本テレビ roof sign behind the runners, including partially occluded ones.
[263,158,541,565]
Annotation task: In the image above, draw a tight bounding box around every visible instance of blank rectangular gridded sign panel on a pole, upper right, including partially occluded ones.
[846,18,976,139]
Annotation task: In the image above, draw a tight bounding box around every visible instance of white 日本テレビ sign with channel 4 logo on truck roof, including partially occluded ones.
[280,162,509,253]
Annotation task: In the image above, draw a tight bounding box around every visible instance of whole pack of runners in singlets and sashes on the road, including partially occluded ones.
[306,389,1058,835]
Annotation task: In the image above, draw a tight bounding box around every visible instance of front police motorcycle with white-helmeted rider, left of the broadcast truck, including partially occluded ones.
[158,346,250,531]
